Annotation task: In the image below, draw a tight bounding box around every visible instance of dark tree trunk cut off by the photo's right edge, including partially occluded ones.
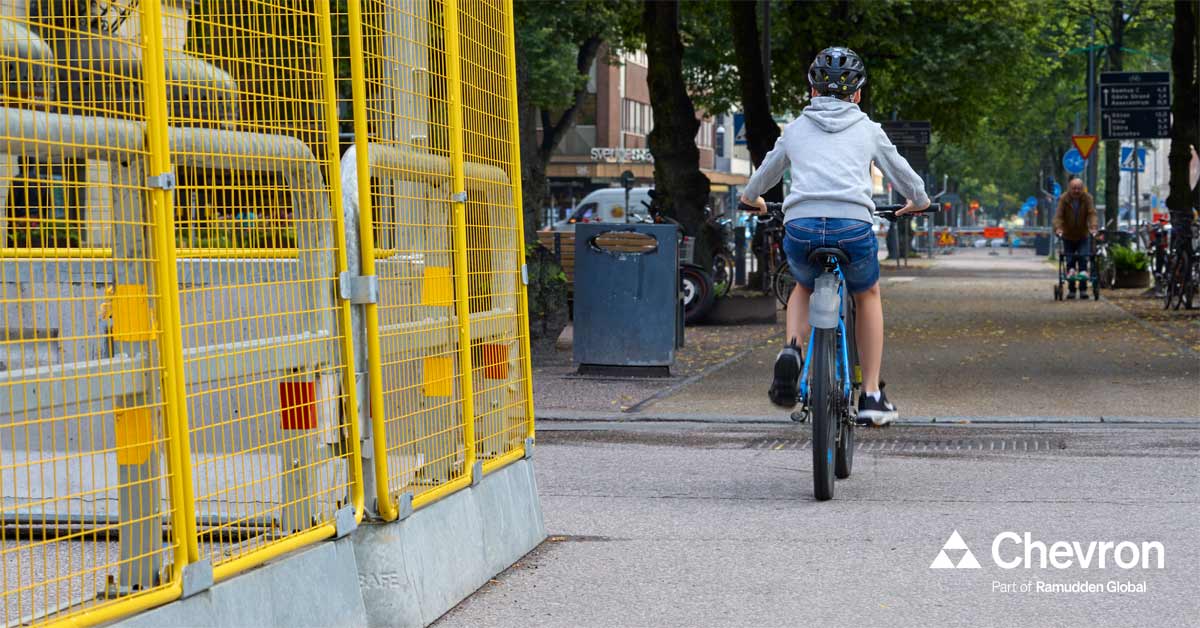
[1166,0,1200,233]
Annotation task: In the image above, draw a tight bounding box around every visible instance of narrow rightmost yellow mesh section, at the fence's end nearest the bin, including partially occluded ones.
[457,0,530,470]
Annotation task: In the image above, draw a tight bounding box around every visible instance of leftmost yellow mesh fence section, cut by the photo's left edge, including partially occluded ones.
[0,0,179,626]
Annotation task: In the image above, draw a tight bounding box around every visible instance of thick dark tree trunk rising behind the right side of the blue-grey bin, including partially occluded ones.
[642,0,713,268]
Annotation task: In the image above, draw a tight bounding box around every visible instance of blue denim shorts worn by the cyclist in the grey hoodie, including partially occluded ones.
[784,219,880,294]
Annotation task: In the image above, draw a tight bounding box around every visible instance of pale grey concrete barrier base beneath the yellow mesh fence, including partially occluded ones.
[113,460,546,628]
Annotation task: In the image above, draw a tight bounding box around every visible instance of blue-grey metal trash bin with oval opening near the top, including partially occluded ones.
[574,223,683,376]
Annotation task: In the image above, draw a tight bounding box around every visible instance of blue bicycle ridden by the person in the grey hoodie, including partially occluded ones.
[767,203,936,501]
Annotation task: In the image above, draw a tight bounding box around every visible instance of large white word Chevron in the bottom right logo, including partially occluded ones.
[991,532,1166,569]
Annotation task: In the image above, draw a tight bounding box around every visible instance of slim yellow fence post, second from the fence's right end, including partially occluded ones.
[442,0,482,483]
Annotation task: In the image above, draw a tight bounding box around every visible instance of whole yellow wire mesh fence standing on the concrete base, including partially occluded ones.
[0,0,533,626]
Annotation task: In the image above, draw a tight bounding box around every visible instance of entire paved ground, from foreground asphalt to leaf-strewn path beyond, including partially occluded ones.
[439,251,1200,627]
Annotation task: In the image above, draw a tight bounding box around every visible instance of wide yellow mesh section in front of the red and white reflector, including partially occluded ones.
[163,0,353,569]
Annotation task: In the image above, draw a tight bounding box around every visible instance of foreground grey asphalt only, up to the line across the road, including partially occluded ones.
[438,423,1200,628]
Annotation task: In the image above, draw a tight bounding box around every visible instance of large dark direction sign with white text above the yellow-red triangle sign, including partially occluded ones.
[1100,72,1171,139]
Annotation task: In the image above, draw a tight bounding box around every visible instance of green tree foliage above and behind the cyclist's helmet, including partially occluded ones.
[682,0,1171,223]
